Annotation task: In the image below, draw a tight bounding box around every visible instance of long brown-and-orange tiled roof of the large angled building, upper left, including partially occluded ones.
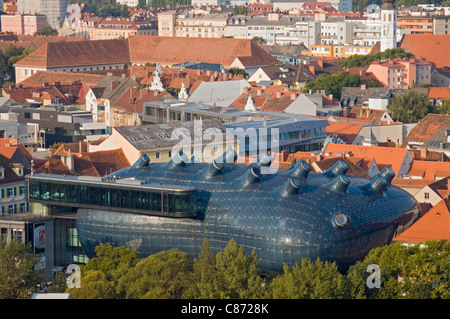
[15,35,279,68]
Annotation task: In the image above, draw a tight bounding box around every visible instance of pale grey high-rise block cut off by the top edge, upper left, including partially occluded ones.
[17,0,69,28]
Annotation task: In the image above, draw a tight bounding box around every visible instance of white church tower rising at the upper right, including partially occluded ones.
[380,0,397,51]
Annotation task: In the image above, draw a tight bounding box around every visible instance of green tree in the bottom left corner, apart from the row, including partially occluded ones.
[0,240,42,299]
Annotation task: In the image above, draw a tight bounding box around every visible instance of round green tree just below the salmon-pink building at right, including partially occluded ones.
[387,90,433,123]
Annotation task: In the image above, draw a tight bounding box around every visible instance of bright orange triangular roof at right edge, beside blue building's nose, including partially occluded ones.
[393,199,450,243]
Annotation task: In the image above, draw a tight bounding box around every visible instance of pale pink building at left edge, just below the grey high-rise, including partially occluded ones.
[0,13,48,35]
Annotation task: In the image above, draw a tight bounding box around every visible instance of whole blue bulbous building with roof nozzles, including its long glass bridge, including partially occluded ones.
[27,150,419,272]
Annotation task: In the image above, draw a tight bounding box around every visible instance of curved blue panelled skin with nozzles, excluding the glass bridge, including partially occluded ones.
[73,157,419,272]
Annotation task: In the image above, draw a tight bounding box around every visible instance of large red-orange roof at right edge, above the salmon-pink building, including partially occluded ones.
[400,34,450,68]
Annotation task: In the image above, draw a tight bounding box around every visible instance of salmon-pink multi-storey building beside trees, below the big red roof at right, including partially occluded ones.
[367,59,431,89]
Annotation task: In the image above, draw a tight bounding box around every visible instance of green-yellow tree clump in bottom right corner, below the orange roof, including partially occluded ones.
[347,240,450,299]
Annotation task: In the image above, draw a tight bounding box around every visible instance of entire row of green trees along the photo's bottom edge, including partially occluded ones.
[0,240,450,299]
